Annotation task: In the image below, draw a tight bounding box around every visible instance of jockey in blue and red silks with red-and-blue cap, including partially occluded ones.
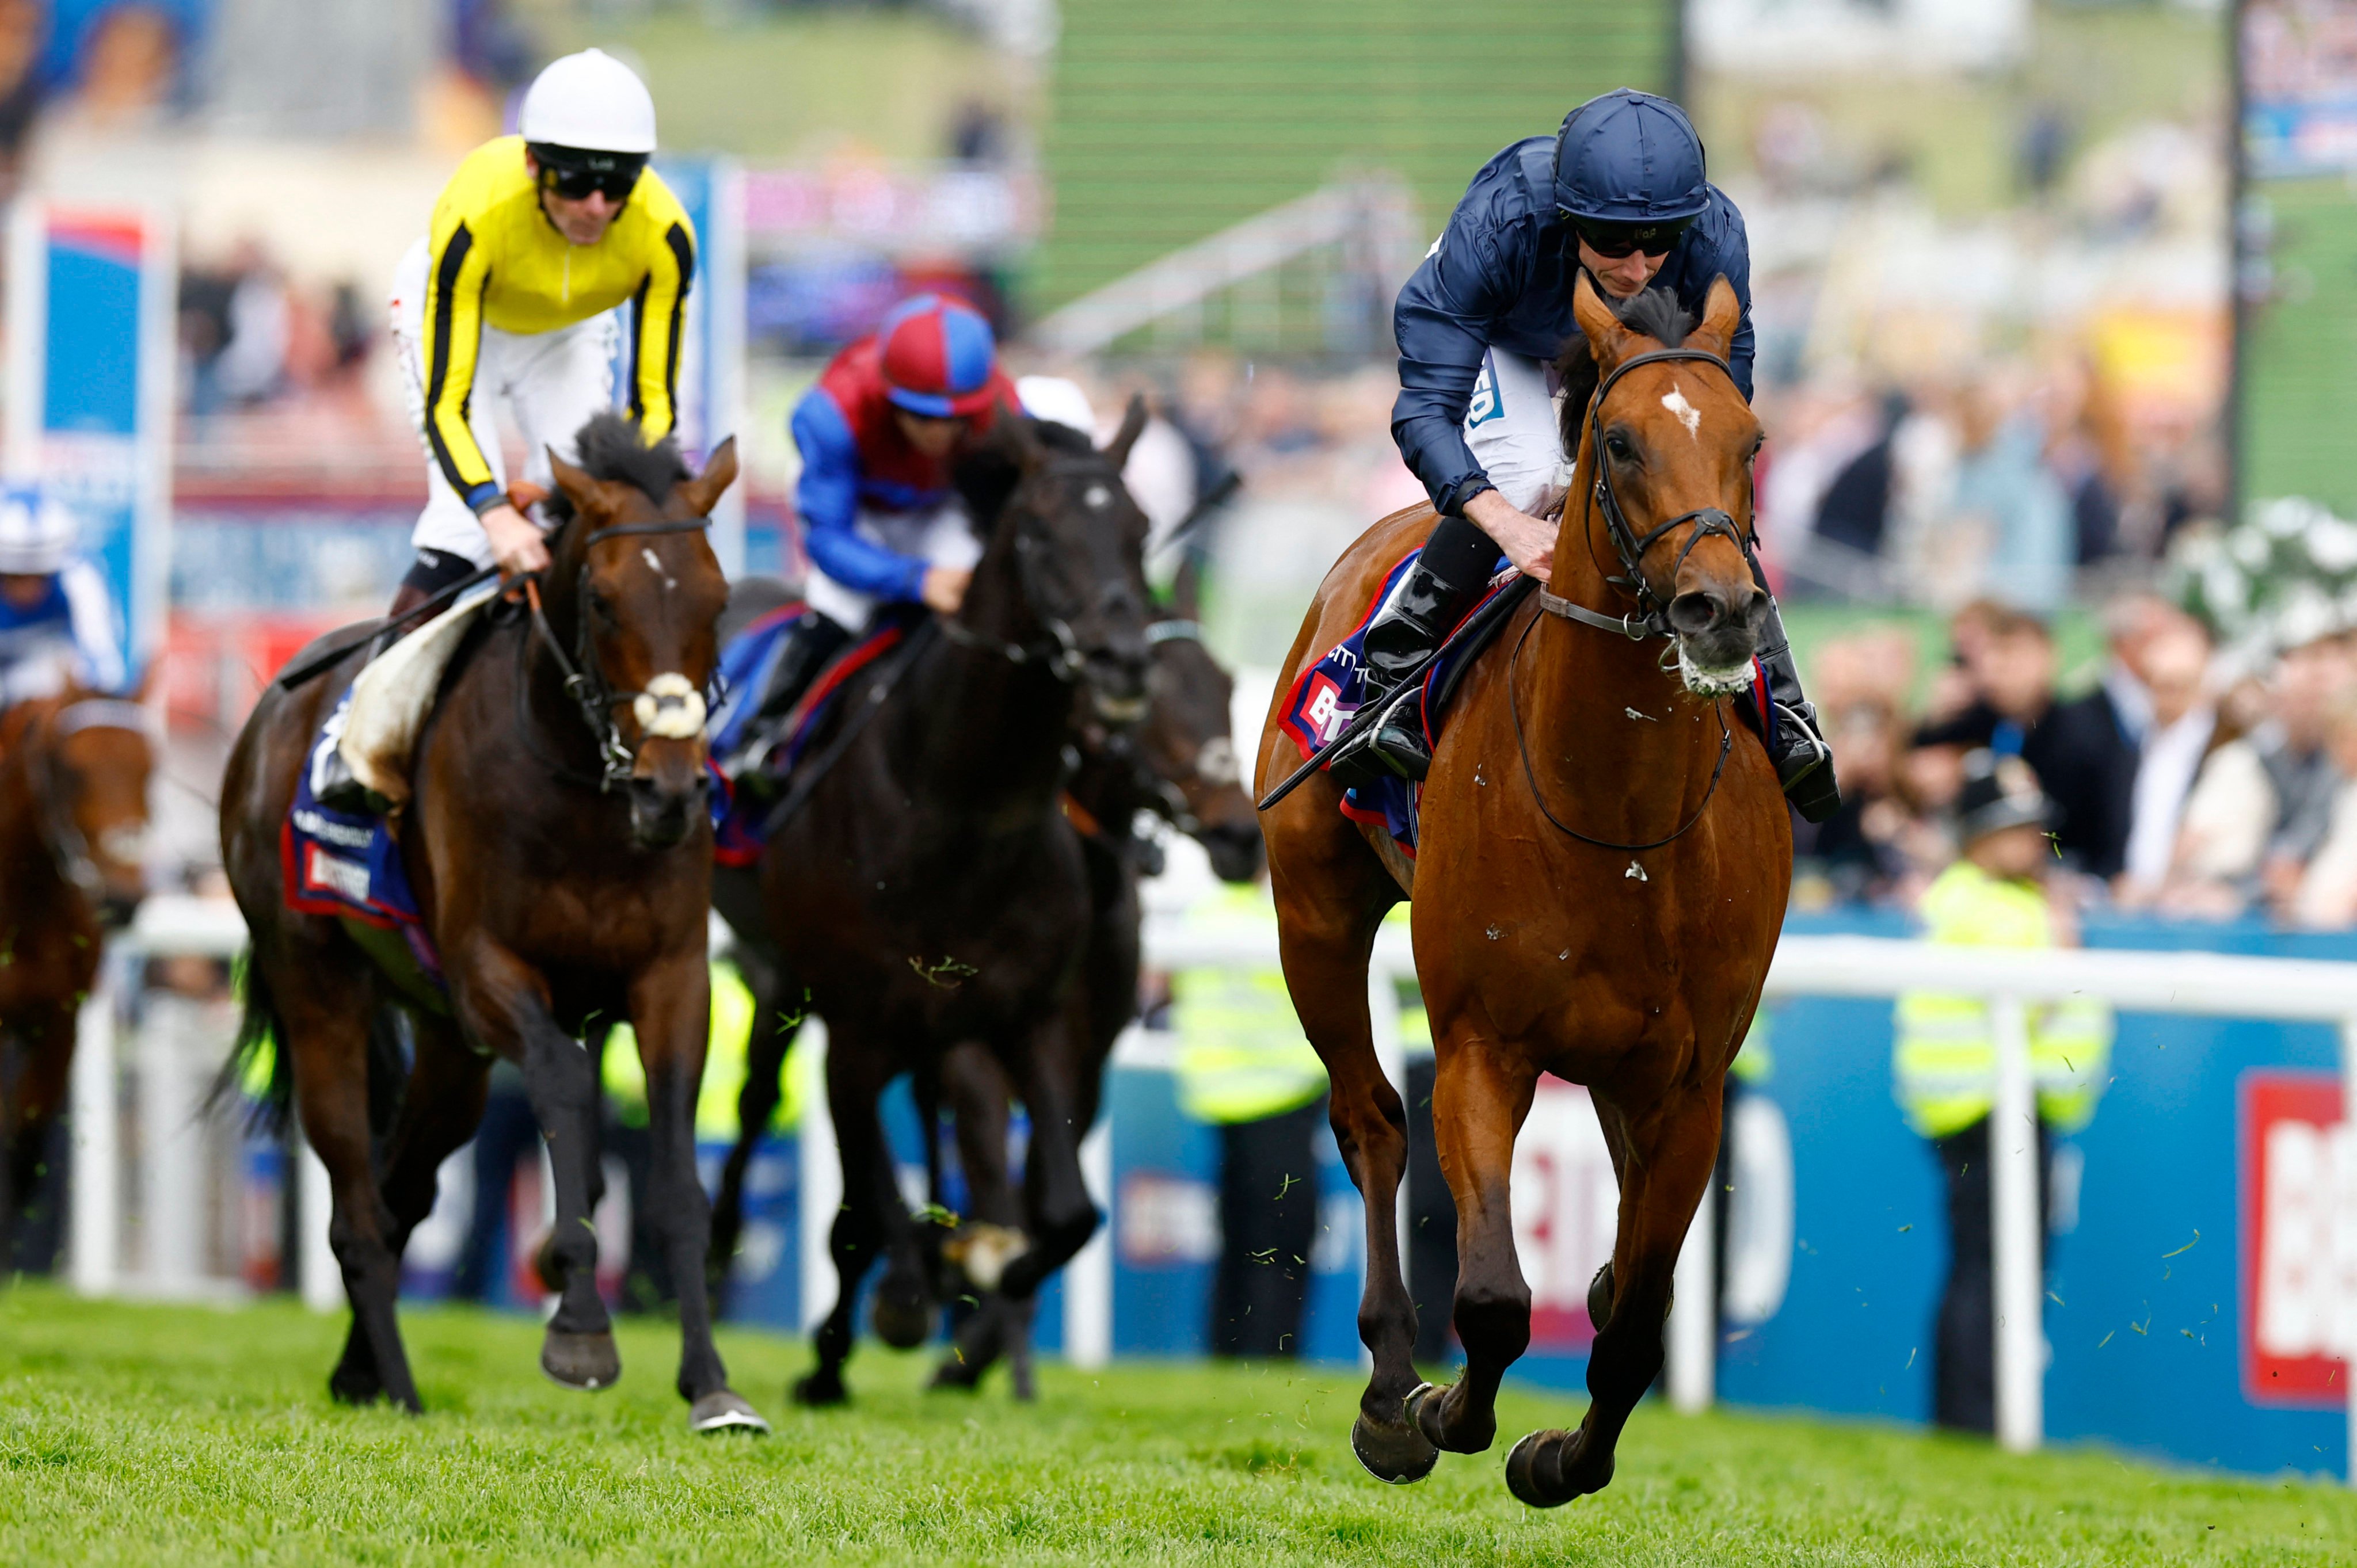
[730,295,1016,759]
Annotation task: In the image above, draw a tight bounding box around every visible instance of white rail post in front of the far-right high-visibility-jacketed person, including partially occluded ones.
[1989,995,2046,1452]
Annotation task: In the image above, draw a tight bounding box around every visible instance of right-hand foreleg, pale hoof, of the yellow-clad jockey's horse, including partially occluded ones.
[629,945,768,1431]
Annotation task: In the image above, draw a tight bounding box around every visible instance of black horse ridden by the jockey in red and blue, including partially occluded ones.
[714,401,1148,1405]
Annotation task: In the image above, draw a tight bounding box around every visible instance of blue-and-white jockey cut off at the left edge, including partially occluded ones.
[0,486,127,707]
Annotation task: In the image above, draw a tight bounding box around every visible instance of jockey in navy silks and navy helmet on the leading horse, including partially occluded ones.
[1343,87,1838,821]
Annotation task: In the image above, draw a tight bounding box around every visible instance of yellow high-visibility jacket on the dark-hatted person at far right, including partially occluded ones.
[1890,861,2114,1139]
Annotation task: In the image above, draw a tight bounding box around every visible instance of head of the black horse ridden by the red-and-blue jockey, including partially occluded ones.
[1002,403,1148,726]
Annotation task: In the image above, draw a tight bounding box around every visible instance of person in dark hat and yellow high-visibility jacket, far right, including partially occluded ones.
[1893,752,2112,1431]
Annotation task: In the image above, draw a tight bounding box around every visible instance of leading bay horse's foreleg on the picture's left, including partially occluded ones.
[1414,1037,1539,1455]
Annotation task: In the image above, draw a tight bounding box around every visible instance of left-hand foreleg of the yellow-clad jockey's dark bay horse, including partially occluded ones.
[450,938,617,1389]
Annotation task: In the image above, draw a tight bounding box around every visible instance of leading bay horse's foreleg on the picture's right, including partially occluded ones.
[1499,1073,1720,1509]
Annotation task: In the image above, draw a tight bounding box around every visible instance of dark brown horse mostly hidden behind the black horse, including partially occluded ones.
[917,566,1261,1398]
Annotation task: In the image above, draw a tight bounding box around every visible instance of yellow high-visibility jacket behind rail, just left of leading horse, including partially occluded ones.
[1171,887,1327,1127]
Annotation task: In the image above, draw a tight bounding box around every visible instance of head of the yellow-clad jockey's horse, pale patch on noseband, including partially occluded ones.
[556,441,736,849]
